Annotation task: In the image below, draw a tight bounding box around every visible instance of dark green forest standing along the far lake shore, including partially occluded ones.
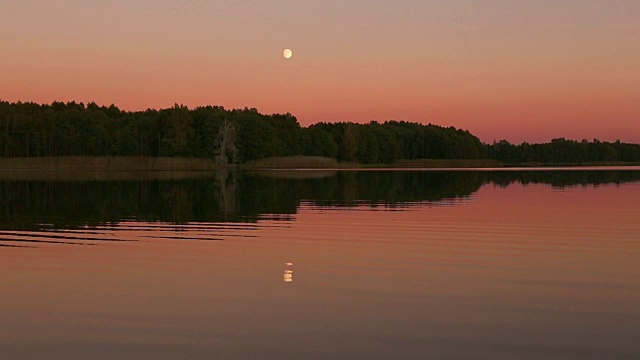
[0,101,640,164]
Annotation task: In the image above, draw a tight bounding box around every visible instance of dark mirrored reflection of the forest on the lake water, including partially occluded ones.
[0,171,640,229]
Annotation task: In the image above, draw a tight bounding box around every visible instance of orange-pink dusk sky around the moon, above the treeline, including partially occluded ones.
[0,0,640,143]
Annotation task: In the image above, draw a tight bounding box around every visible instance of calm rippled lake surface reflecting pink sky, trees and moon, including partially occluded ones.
[0,168,640,359]
